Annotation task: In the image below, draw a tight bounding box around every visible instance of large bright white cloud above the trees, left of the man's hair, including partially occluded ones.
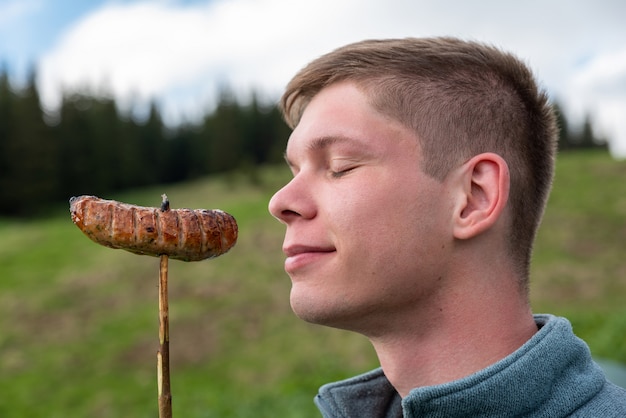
[40,0,360,119]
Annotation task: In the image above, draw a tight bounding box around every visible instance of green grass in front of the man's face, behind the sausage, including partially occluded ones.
[0,168,376,418]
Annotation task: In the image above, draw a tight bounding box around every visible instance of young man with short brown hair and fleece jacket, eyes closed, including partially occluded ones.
[269,38,626,418]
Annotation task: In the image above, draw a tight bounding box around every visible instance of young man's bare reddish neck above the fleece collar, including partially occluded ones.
[369,270,537,397]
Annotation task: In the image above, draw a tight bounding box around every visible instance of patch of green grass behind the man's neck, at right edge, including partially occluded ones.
[531,152,626,363]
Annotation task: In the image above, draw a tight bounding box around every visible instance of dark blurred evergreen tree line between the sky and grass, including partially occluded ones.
[0,70,606,216]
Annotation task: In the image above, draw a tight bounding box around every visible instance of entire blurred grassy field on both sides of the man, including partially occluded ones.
[0,153,626,418]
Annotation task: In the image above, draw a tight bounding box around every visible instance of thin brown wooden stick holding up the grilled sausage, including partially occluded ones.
[157,195,172,418]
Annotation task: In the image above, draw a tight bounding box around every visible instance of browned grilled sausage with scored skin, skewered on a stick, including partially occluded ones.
[70,196,238,261]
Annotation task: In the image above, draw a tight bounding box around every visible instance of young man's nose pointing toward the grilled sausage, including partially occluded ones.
[268,176,315,224]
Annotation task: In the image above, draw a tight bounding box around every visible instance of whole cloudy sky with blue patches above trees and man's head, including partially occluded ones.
[0,0,626,157]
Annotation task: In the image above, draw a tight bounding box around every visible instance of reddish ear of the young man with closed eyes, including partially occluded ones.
[454,153,510,239]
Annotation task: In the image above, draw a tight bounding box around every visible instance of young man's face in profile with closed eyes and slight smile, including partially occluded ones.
[269,83,452,333]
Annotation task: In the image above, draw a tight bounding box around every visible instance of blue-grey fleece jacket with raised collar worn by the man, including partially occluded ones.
[315,315,626,418]
